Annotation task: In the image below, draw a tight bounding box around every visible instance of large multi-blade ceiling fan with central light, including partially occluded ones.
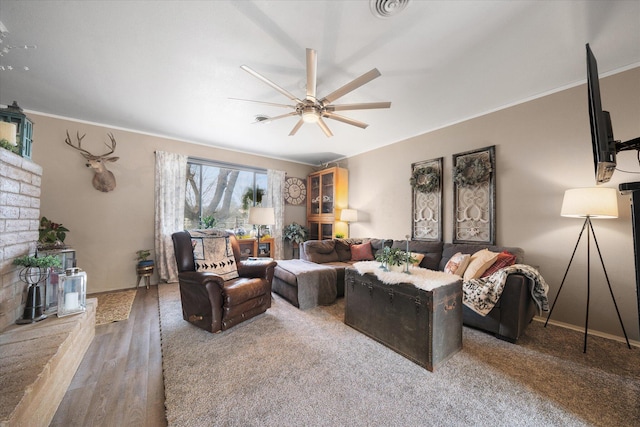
[232,48,391,137]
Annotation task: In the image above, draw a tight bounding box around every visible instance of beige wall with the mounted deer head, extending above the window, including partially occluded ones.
[27,113,312,293]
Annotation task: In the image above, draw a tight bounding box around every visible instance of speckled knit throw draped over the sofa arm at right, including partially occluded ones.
[462,264,549,316]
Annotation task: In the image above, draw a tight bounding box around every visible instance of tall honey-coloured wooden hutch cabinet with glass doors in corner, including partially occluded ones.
[307,167,349,240]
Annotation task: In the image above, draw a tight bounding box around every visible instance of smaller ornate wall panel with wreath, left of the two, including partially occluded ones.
[411,157,442,241]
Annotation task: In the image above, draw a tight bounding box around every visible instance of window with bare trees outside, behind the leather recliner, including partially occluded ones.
[184,159,267,234]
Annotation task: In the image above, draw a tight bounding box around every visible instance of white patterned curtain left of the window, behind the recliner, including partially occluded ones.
[155,151,188,282]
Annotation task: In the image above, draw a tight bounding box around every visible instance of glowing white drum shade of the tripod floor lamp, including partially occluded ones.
[560,187,618,218]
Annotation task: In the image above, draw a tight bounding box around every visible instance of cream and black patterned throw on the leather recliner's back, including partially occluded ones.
[189,229,240,281]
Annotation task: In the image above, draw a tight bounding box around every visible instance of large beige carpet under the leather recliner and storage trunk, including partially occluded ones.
[158,284,640,427]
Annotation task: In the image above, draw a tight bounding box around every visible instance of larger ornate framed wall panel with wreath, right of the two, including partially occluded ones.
[453,146,496,245]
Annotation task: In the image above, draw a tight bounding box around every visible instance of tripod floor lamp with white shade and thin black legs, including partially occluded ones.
[544,187,631,353]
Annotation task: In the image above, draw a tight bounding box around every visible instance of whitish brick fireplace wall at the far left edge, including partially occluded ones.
[0,148,42,331]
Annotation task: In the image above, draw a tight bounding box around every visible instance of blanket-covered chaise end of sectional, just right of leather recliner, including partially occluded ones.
[271,259,337,310]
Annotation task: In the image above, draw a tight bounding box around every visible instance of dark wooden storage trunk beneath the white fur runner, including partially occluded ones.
[344,268,462,371]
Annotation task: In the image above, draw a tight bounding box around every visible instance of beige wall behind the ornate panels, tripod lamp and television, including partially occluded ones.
[348,68,640,340]
